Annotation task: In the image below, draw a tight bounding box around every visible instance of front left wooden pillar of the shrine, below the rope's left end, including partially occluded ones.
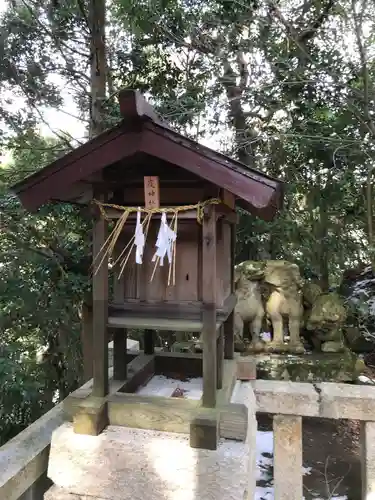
[92,207,108,398]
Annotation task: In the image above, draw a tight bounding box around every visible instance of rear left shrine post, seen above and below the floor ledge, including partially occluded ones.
[113,258,127,380]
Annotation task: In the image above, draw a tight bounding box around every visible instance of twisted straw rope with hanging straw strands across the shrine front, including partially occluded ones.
[92,198,221,286]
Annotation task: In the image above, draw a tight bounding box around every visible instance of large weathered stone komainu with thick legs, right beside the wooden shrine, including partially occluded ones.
[234,260,304,353]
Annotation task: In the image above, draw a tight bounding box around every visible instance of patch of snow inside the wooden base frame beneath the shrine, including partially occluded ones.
[137,375,203,400]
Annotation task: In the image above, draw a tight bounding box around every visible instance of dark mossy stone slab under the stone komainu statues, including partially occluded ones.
[251,351,364,383]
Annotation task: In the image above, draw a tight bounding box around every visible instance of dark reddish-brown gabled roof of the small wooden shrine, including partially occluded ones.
[12,91,283,220]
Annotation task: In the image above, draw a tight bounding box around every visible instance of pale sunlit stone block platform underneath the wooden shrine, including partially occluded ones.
[44,382,257,500]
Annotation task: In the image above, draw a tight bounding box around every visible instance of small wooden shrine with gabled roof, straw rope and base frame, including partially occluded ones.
[13,91,282,449]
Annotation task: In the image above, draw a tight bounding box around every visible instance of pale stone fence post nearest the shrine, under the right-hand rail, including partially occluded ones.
[273,415,303,500]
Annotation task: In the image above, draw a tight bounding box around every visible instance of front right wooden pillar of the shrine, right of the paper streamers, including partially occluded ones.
[202,205,217,408]
